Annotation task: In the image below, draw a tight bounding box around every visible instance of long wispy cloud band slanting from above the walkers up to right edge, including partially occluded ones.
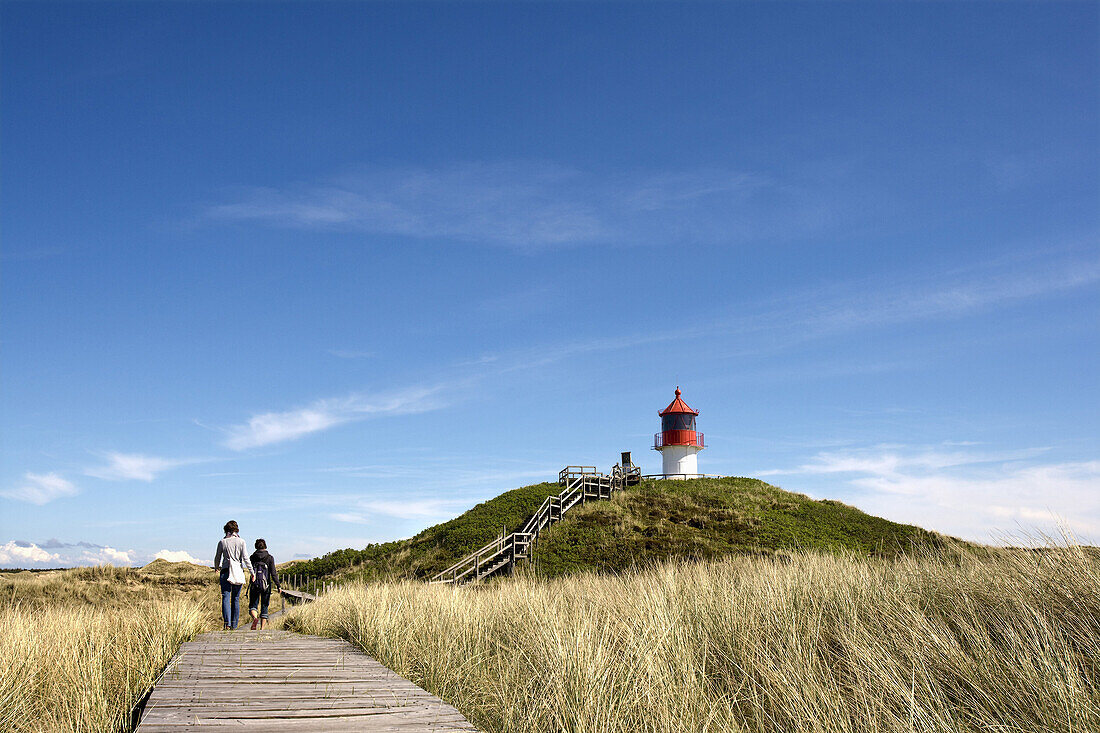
[204,252,1100,450]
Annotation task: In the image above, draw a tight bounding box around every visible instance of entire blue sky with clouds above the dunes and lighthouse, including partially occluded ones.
[0,2,1100,567]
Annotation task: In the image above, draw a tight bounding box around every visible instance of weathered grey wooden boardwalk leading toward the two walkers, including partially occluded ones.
[138,631,476,733]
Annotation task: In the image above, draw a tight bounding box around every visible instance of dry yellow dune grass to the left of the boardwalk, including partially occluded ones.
[0,564,220,733]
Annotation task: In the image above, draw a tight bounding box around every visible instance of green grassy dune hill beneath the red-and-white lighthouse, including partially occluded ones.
[286,478,946,579]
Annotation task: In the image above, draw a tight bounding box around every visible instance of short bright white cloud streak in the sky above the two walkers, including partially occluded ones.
[224,386,443,450]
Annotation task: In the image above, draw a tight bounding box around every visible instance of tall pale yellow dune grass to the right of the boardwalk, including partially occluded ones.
[285,547,1100,733]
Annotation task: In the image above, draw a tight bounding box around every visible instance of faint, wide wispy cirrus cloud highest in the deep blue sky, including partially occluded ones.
[206,161,783,248]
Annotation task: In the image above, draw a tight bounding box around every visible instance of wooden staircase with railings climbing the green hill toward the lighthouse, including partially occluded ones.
[430,466,641,584]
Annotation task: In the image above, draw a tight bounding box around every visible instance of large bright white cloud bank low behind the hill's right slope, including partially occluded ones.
[767,446,1100,541]
